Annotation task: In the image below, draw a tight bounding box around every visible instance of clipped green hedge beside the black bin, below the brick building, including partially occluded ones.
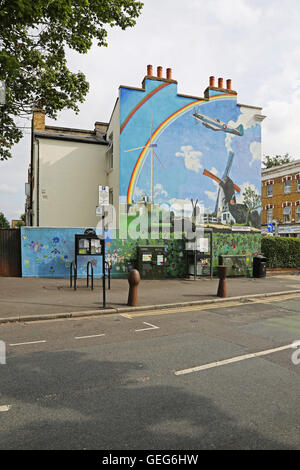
[261,237,300,268]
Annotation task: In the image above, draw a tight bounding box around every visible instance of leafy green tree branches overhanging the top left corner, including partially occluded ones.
[0,0,143,160]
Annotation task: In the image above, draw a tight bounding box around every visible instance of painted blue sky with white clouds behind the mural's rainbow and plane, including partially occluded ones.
[121,90,260,212]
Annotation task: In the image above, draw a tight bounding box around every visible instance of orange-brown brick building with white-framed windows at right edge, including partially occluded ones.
[262,160,300,237]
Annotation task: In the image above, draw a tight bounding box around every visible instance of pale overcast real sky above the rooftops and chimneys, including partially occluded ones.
[0,0,300,221]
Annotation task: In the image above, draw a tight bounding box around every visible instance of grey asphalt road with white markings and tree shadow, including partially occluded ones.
[0,295,300,450]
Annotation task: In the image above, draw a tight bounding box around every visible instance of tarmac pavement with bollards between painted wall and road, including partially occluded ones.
[0,273,300,322]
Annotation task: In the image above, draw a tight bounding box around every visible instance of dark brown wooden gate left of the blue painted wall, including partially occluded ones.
[0,228,22,277]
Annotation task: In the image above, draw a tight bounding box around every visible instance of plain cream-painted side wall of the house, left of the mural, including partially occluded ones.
[33,138,109,227]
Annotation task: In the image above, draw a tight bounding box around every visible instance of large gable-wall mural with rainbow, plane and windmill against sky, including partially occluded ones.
[120,79,261,229]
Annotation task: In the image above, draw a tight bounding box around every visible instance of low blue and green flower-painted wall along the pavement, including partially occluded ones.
[21,227,260,278]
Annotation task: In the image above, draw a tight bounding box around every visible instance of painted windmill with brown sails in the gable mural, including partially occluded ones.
[203,152,241,223]
